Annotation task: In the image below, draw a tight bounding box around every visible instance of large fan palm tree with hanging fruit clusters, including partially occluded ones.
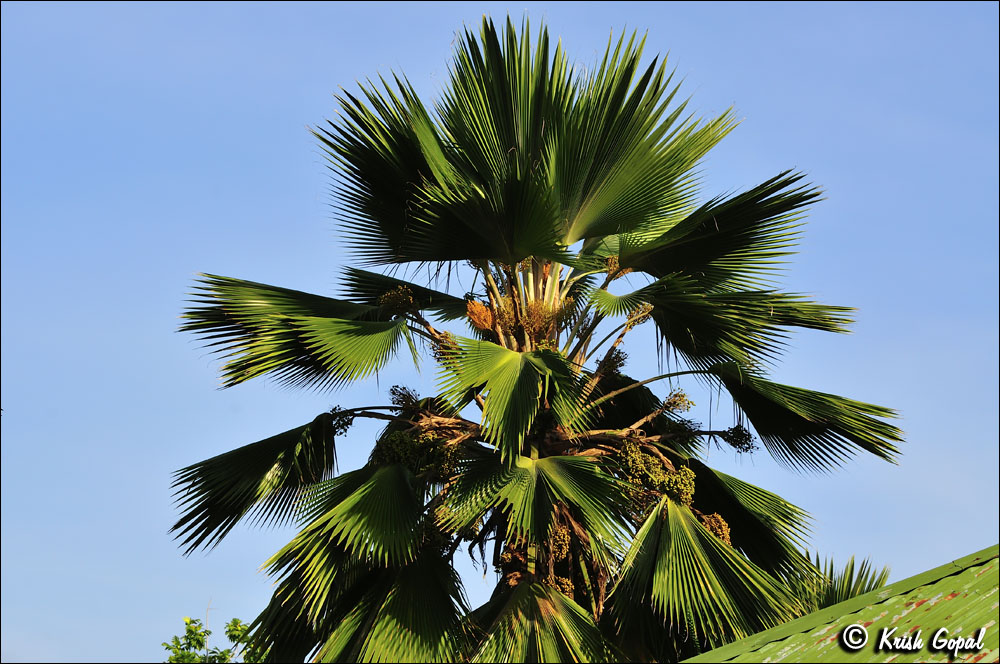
[174,19,901,662]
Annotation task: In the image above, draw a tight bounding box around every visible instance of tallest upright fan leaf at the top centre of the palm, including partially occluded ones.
[433,20,572,265]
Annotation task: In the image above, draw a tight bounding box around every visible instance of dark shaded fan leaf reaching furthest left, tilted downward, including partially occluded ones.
[171,413,336,553]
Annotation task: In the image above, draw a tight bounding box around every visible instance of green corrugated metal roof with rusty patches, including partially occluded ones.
[685,546,1000,662]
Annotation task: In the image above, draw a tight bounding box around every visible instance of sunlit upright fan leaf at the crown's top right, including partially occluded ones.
[549,35,734,244]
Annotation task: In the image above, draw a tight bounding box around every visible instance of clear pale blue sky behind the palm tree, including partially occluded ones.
[0,2,998,662]
